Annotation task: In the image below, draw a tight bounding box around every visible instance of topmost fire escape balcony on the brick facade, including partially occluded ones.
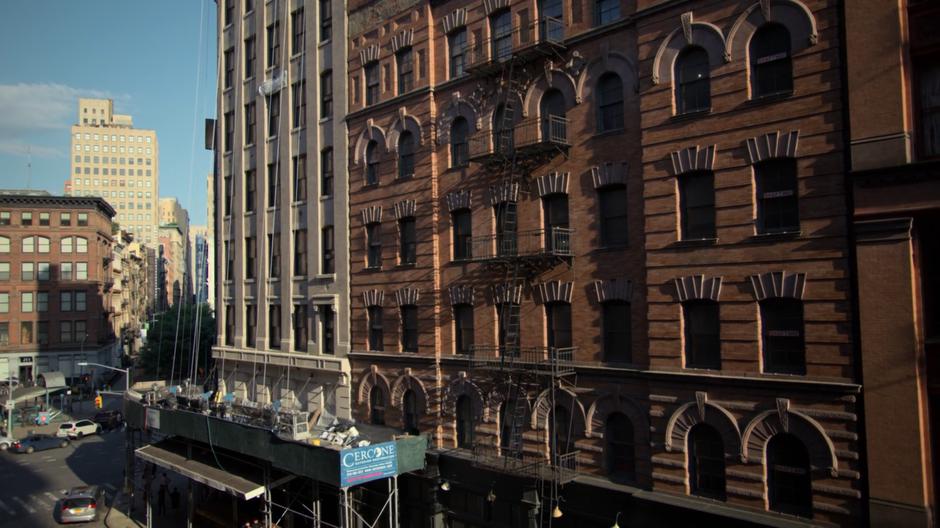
[466,17,565,76]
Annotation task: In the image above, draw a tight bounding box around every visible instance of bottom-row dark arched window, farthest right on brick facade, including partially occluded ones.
[767,433,813,517]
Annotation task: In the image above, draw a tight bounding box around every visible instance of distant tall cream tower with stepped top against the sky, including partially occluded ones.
[65,99,160,244]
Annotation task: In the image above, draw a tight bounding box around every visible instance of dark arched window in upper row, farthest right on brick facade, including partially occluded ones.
[748,24,793,98]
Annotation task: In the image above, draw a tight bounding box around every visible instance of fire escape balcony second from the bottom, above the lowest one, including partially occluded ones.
[470,345,577,377]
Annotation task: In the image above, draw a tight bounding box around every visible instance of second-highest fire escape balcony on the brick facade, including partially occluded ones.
[468,115,571,164]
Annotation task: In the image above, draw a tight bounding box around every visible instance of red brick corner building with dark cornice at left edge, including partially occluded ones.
[0,193,119,383]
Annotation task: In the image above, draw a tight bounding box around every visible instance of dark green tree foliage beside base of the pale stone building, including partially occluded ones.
[138,303,216,383]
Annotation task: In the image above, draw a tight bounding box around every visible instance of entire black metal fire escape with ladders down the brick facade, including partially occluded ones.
[458,17,577,525]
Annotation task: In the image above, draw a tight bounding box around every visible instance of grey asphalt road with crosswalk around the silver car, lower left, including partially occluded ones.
[0,424,125,528]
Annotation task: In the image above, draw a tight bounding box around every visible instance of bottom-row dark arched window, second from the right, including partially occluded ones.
[687,423,725,500]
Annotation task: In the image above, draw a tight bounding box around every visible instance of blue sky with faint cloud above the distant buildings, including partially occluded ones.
[0,0,216,225]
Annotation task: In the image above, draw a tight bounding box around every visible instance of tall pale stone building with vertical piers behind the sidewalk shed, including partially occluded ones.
[212,0,351,417]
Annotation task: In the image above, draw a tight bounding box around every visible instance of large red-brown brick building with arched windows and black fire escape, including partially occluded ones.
[347,0,865,526]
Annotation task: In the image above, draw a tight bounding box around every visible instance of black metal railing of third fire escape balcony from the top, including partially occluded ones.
[467,227,574,261]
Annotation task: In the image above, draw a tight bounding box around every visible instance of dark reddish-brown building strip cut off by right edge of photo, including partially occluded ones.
[845,0,940,526]
